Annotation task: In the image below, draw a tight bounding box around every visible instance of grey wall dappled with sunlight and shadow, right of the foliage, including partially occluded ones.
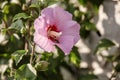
[80,0,120,80]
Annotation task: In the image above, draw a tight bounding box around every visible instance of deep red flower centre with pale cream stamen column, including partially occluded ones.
[47,25,62,43]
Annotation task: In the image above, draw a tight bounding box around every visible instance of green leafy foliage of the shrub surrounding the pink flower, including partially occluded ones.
[0,0,120,80]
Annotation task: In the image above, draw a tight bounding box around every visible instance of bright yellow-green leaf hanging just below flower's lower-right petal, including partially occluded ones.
[69,47,81,67]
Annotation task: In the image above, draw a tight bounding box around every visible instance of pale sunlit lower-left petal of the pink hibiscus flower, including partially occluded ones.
[34,32,55,52]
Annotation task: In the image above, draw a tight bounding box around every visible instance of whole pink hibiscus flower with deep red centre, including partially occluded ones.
[34,6,80,55]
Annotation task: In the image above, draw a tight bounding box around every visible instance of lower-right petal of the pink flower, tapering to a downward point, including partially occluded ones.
[56,36,74,55]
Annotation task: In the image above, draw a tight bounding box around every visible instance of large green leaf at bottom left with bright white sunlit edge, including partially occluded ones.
[15,64,37,80]
